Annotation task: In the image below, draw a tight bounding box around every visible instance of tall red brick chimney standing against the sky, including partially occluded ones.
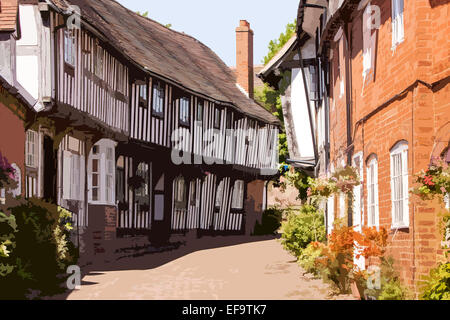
[236,20,254,99]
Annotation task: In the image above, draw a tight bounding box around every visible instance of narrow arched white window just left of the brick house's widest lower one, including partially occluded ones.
[367,155,380,228]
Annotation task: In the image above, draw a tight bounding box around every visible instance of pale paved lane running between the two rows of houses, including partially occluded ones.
[63,238,356,300]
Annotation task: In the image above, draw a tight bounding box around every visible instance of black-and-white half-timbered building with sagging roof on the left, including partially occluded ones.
[3,0,279,260]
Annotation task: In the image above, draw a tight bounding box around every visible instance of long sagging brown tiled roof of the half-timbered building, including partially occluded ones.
[53,0,279,124]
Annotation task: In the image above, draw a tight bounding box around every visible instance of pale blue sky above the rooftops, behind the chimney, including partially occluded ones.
[118,0,299,66]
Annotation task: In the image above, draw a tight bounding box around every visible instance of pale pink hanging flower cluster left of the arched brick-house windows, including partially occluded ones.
[307,167,361,198]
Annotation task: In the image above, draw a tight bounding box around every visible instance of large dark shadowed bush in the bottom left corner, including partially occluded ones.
[0,199,78,299]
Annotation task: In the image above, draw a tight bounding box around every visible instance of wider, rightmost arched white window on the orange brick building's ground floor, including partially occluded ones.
[391,141,409,229]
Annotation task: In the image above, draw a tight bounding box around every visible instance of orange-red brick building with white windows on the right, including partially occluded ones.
[263,0,450,293]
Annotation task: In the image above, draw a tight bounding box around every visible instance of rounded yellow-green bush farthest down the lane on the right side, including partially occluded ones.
[281,205,326,257]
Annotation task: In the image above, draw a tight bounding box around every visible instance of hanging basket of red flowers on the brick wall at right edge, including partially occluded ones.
[411,161,450,200]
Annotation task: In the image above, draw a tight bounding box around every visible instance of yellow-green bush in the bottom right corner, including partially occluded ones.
[421,263,450,300]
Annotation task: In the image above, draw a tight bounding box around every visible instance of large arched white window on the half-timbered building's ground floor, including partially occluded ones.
[88,139,116,205]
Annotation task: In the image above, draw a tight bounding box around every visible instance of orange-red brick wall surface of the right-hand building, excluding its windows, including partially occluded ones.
[330,0,450,291]
